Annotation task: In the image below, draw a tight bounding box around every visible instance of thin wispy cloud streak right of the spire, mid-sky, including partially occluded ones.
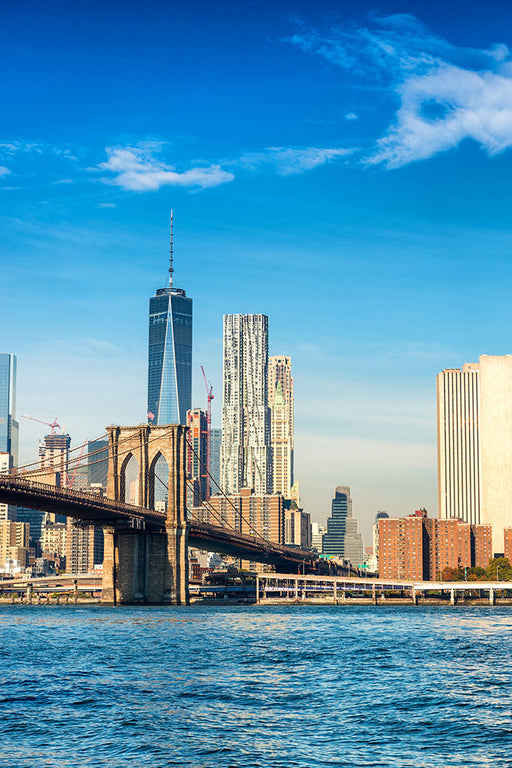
[239,147,355,176]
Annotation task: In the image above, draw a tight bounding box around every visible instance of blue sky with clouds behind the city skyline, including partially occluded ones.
[0,0,512,534]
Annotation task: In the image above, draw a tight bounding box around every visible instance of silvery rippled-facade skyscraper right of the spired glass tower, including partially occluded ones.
[221,315,273,495]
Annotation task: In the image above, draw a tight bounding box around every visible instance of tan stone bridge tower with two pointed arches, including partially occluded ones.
[102,424,189,605]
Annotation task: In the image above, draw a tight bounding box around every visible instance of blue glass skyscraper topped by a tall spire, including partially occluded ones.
[148,211,192,424]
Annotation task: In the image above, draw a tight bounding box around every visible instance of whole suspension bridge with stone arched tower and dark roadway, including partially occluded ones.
[0,425,318,605]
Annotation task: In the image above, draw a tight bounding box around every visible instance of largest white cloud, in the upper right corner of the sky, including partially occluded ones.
[289,14,512,168]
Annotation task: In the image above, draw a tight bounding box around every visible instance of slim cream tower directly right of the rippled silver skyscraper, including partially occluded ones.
[268,355,294,499]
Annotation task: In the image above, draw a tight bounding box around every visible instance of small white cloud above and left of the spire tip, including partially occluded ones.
[98,145,234,192]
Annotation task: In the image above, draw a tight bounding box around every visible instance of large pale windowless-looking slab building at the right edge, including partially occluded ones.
[437,355,512,554]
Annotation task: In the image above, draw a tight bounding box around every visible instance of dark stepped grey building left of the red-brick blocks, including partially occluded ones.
[322,485,364,567]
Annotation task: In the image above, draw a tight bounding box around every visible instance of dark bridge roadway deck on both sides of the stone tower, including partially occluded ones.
[0,474,318,572]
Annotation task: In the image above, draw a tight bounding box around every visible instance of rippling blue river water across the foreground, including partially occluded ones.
[0,606,512,768]
